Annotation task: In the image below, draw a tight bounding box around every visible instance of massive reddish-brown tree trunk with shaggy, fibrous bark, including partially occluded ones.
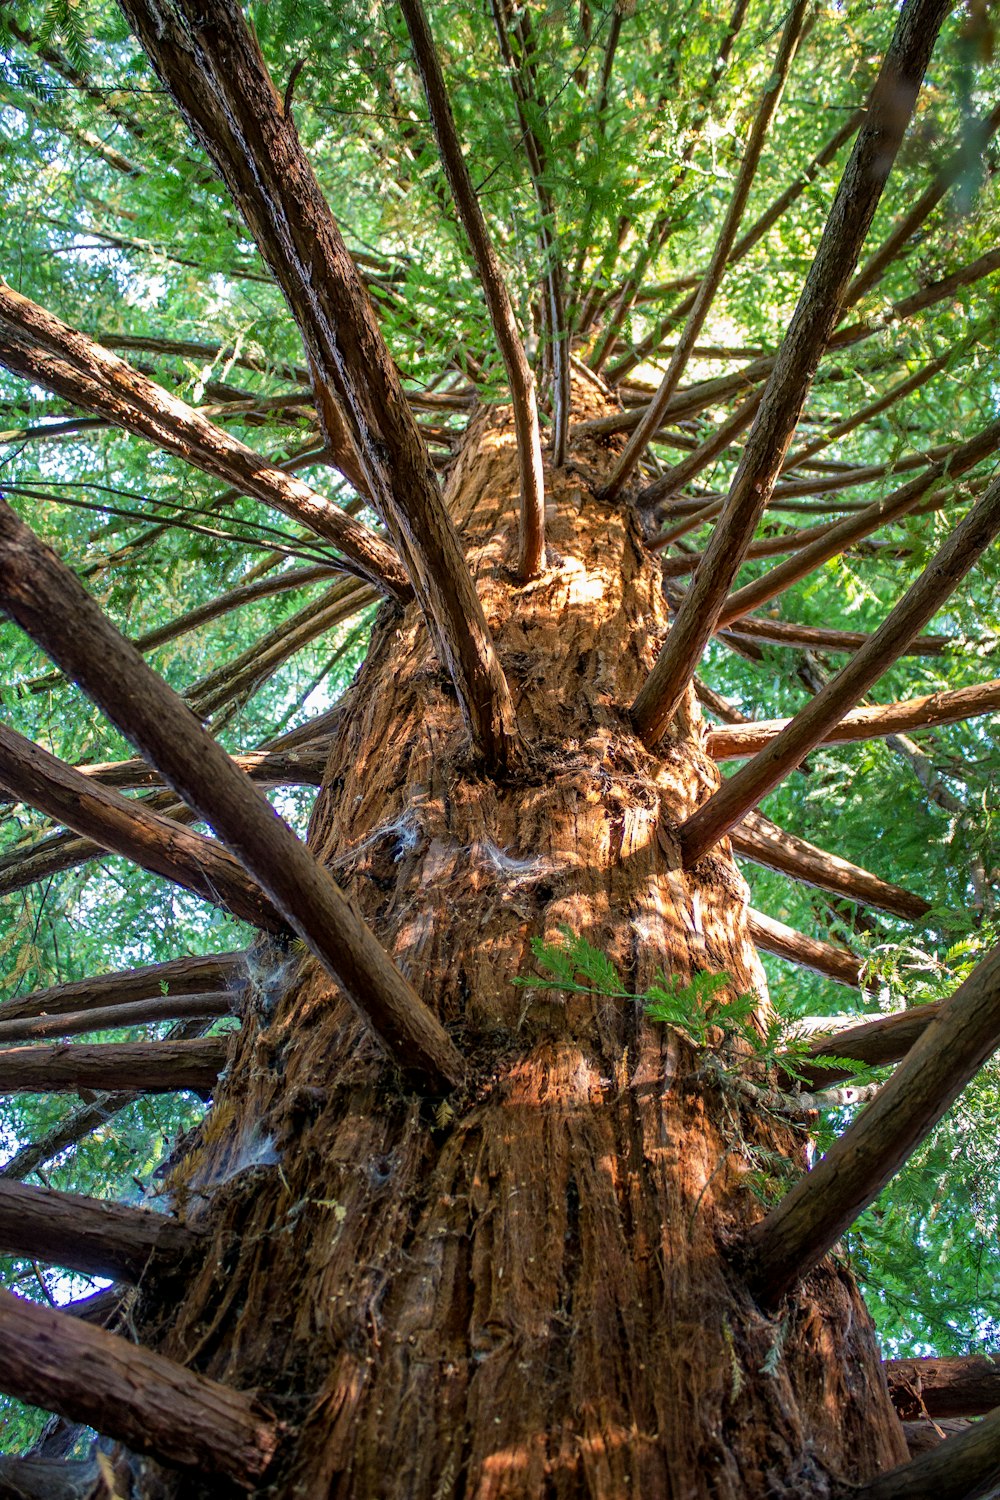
[138,386,906,1500]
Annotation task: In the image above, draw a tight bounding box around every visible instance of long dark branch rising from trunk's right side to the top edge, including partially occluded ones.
[633,0,949,744]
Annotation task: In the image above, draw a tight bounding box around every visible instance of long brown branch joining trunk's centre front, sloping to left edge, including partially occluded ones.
[0,503,463,1089]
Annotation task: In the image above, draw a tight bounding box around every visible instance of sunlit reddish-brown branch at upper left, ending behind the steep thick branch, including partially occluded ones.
[0,282,409,599]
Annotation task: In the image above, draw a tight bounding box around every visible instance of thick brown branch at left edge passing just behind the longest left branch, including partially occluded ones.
[0,725,285,932]
